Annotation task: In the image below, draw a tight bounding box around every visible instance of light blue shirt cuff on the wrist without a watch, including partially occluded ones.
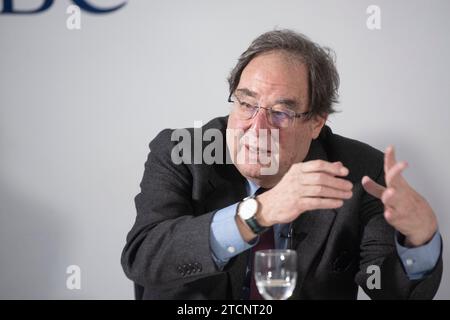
[395,231,442,280]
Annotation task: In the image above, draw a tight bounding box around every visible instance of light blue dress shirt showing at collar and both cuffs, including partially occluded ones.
[209,180,442,280]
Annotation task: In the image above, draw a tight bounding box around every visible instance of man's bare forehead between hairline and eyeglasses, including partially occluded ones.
[238,52,308,100]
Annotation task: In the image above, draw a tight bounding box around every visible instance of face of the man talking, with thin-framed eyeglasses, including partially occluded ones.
[227,51,326,188]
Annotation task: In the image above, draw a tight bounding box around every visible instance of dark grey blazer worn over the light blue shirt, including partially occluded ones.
[121,117,442,299]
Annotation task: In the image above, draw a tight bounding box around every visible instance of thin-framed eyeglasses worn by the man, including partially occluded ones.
[228,94,311,128]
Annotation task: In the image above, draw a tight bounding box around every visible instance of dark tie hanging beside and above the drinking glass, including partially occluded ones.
[243,188,275,300]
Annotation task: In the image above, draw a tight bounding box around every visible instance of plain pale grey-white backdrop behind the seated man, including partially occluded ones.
[0,0,450,299]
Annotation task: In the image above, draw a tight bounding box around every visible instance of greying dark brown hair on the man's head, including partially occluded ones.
[228,29,339,116]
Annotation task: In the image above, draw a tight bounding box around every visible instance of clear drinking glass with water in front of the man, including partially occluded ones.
[253,250,297,300]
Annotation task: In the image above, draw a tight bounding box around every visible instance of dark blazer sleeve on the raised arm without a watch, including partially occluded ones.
[355,164,442,299]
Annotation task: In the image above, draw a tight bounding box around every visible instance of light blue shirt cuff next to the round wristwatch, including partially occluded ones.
[209,203,256,269]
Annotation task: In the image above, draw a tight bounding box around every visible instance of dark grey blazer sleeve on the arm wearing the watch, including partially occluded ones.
[121,130,223,288]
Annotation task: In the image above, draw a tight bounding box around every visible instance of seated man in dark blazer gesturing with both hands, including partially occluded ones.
[122,30,442,299]
